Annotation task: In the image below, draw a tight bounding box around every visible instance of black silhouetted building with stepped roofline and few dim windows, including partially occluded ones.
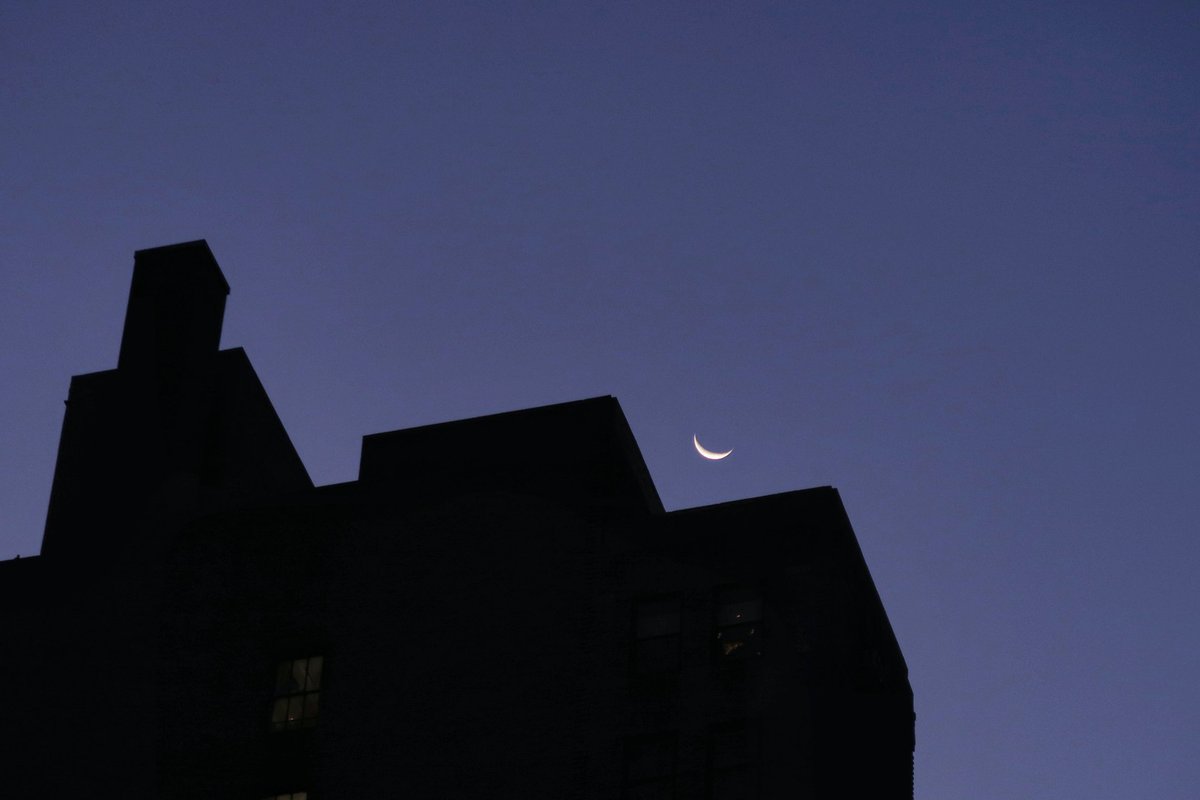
[0,241,914,800]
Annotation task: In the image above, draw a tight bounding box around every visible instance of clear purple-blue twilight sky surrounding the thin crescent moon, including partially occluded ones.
[0,0,1200,800]
